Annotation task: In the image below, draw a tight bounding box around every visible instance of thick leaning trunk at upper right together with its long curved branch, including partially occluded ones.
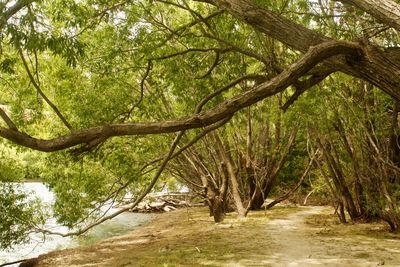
[0,0,400,151]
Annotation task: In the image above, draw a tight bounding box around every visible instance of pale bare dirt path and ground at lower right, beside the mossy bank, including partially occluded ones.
[263,207,400,267]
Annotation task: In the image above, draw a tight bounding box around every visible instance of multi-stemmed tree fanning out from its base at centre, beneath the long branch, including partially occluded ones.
[168,97,298,222]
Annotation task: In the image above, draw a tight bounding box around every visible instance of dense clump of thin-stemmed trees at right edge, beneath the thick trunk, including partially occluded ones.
[309,77,399,231]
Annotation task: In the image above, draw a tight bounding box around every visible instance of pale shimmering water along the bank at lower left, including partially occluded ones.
[0,182,153,266]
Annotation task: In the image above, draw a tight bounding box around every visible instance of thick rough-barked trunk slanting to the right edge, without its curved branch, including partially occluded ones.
[208,0,400,100]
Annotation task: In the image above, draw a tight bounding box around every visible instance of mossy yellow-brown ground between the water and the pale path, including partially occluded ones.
[39,207,290,266]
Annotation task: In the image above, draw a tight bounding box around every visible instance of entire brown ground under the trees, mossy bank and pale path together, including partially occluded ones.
[35,206,400,267]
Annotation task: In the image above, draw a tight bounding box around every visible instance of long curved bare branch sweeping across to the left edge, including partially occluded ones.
[0,41,363,152]
